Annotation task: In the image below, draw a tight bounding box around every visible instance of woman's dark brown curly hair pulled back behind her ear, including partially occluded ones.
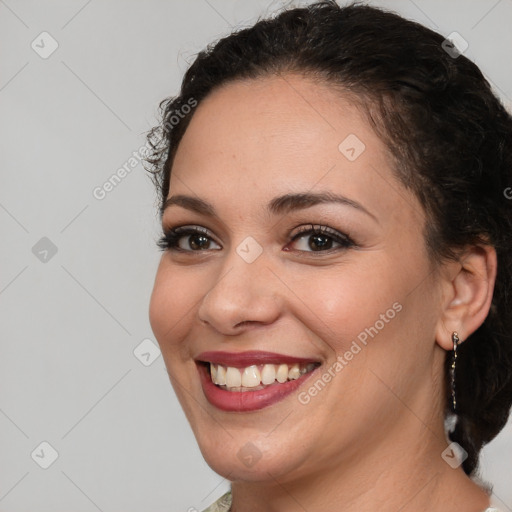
[146,0,512,475]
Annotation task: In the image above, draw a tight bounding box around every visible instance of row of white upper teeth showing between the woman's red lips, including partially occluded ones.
[210,363,316,391]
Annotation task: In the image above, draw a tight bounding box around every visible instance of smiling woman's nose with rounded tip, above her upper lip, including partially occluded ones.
[198,251,283,336]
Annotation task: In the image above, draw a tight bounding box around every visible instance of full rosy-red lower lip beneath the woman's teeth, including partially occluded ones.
[197,363,319,412]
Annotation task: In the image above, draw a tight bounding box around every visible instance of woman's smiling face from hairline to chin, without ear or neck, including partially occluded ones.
[150,74,443,482]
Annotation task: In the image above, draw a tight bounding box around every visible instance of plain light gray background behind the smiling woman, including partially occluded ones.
[0,0,512,512]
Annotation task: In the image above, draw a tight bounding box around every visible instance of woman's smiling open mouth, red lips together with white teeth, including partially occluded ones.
[196,351,321,412]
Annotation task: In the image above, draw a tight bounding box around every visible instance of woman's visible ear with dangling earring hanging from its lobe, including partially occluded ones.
[436,245,498,350]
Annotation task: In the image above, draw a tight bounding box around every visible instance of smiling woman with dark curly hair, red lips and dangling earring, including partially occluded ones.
[144,2,512,512]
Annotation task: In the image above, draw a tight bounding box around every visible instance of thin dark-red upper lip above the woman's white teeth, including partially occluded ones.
[195,350,320,368]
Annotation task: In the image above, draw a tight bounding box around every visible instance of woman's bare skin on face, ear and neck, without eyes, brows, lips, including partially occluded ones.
[150,74,496,512]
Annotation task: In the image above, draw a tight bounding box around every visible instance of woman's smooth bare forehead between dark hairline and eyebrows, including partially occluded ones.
[171,75,422,226]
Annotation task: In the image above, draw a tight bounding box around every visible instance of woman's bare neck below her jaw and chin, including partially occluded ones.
[231,412,489,512]
